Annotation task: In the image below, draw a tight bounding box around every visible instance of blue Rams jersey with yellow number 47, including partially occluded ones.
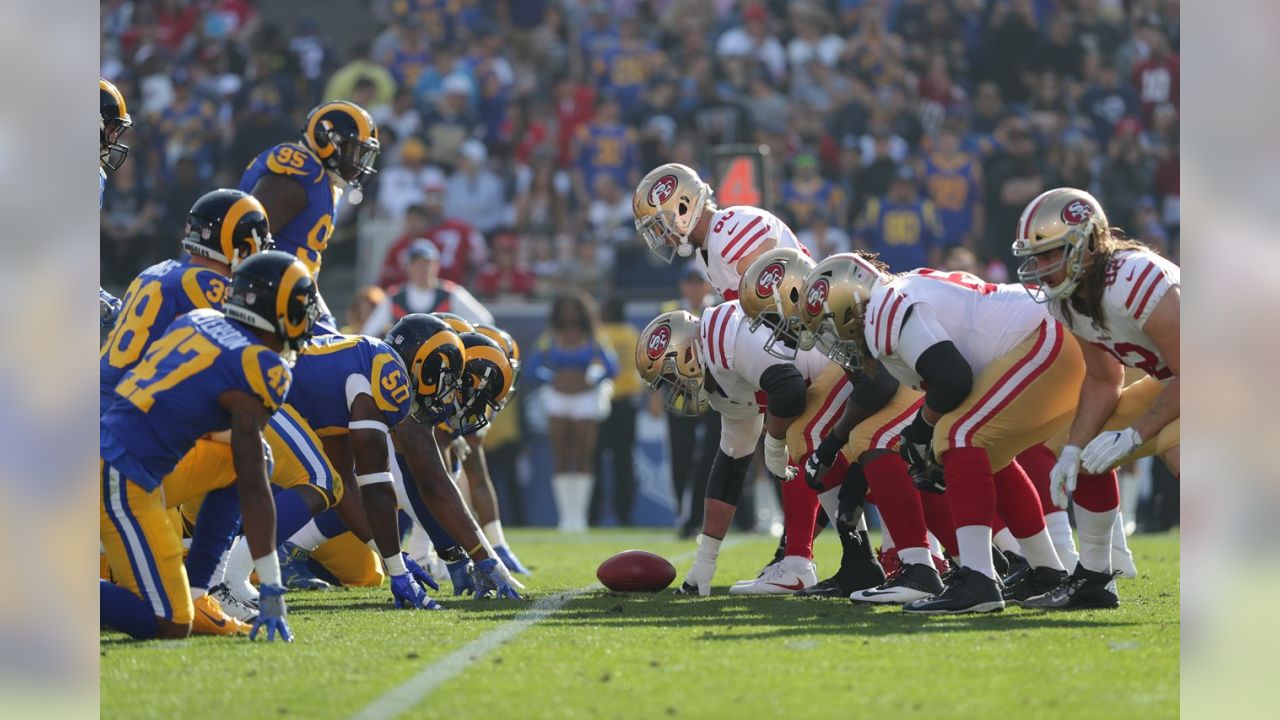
[101,309,291,491]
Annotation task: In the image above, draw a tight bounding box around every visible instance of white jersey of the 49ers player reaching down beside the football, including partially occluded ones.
[699,300,831,445]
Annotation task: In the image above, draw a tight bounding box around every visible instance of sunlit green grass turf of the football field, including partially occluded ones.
[101,530,1179,720]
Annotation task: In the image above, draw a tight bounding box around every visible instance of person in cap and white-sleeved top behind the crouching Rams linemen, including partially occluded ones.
[360,238,493,337]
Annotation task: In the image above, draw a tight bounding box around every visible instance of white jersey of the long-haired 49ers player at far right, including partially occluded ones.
[1050,250,1181,382]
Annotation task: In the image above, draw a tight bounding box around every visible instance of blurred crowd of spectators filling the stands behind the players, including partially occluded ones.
[101,0,1180,300]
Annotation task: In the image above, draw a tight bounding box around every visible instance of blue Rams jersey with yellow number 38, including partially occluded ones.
[99,259,228,413]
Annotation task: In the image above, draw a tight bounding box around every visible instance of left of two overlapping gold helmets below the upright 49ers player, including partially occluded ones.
[737,247,814,360]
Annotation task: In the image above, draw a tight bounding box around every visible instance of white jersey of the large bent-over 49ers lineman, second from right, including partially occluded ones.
[863,268,1050,389]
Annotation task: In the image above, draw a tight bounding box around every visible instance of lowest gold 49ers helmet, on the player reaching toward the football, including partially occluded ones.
[636,310,704,416]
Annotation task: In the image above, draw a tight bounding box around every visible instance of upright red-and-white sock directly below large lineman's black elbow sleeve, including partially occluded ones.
[942,447,996,578]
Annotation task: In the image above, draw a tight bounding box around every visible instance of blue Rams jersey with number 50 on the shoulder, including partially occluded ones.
[289,334,412,437]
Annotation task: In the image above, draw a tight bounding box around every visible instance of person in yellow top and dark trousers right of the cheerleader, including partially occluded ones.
[590,297,645,525]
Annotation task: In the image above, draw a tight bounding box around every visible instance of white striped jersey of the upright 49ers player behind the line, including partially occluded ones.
[698,205,809,300]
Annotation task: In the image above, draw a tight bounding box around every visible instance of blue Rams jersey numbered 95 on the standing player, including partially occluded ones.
[239,142,342,274]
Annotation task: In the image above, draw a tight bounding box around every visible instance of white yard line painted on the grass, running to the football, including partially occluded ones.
[351,538,737,720]
